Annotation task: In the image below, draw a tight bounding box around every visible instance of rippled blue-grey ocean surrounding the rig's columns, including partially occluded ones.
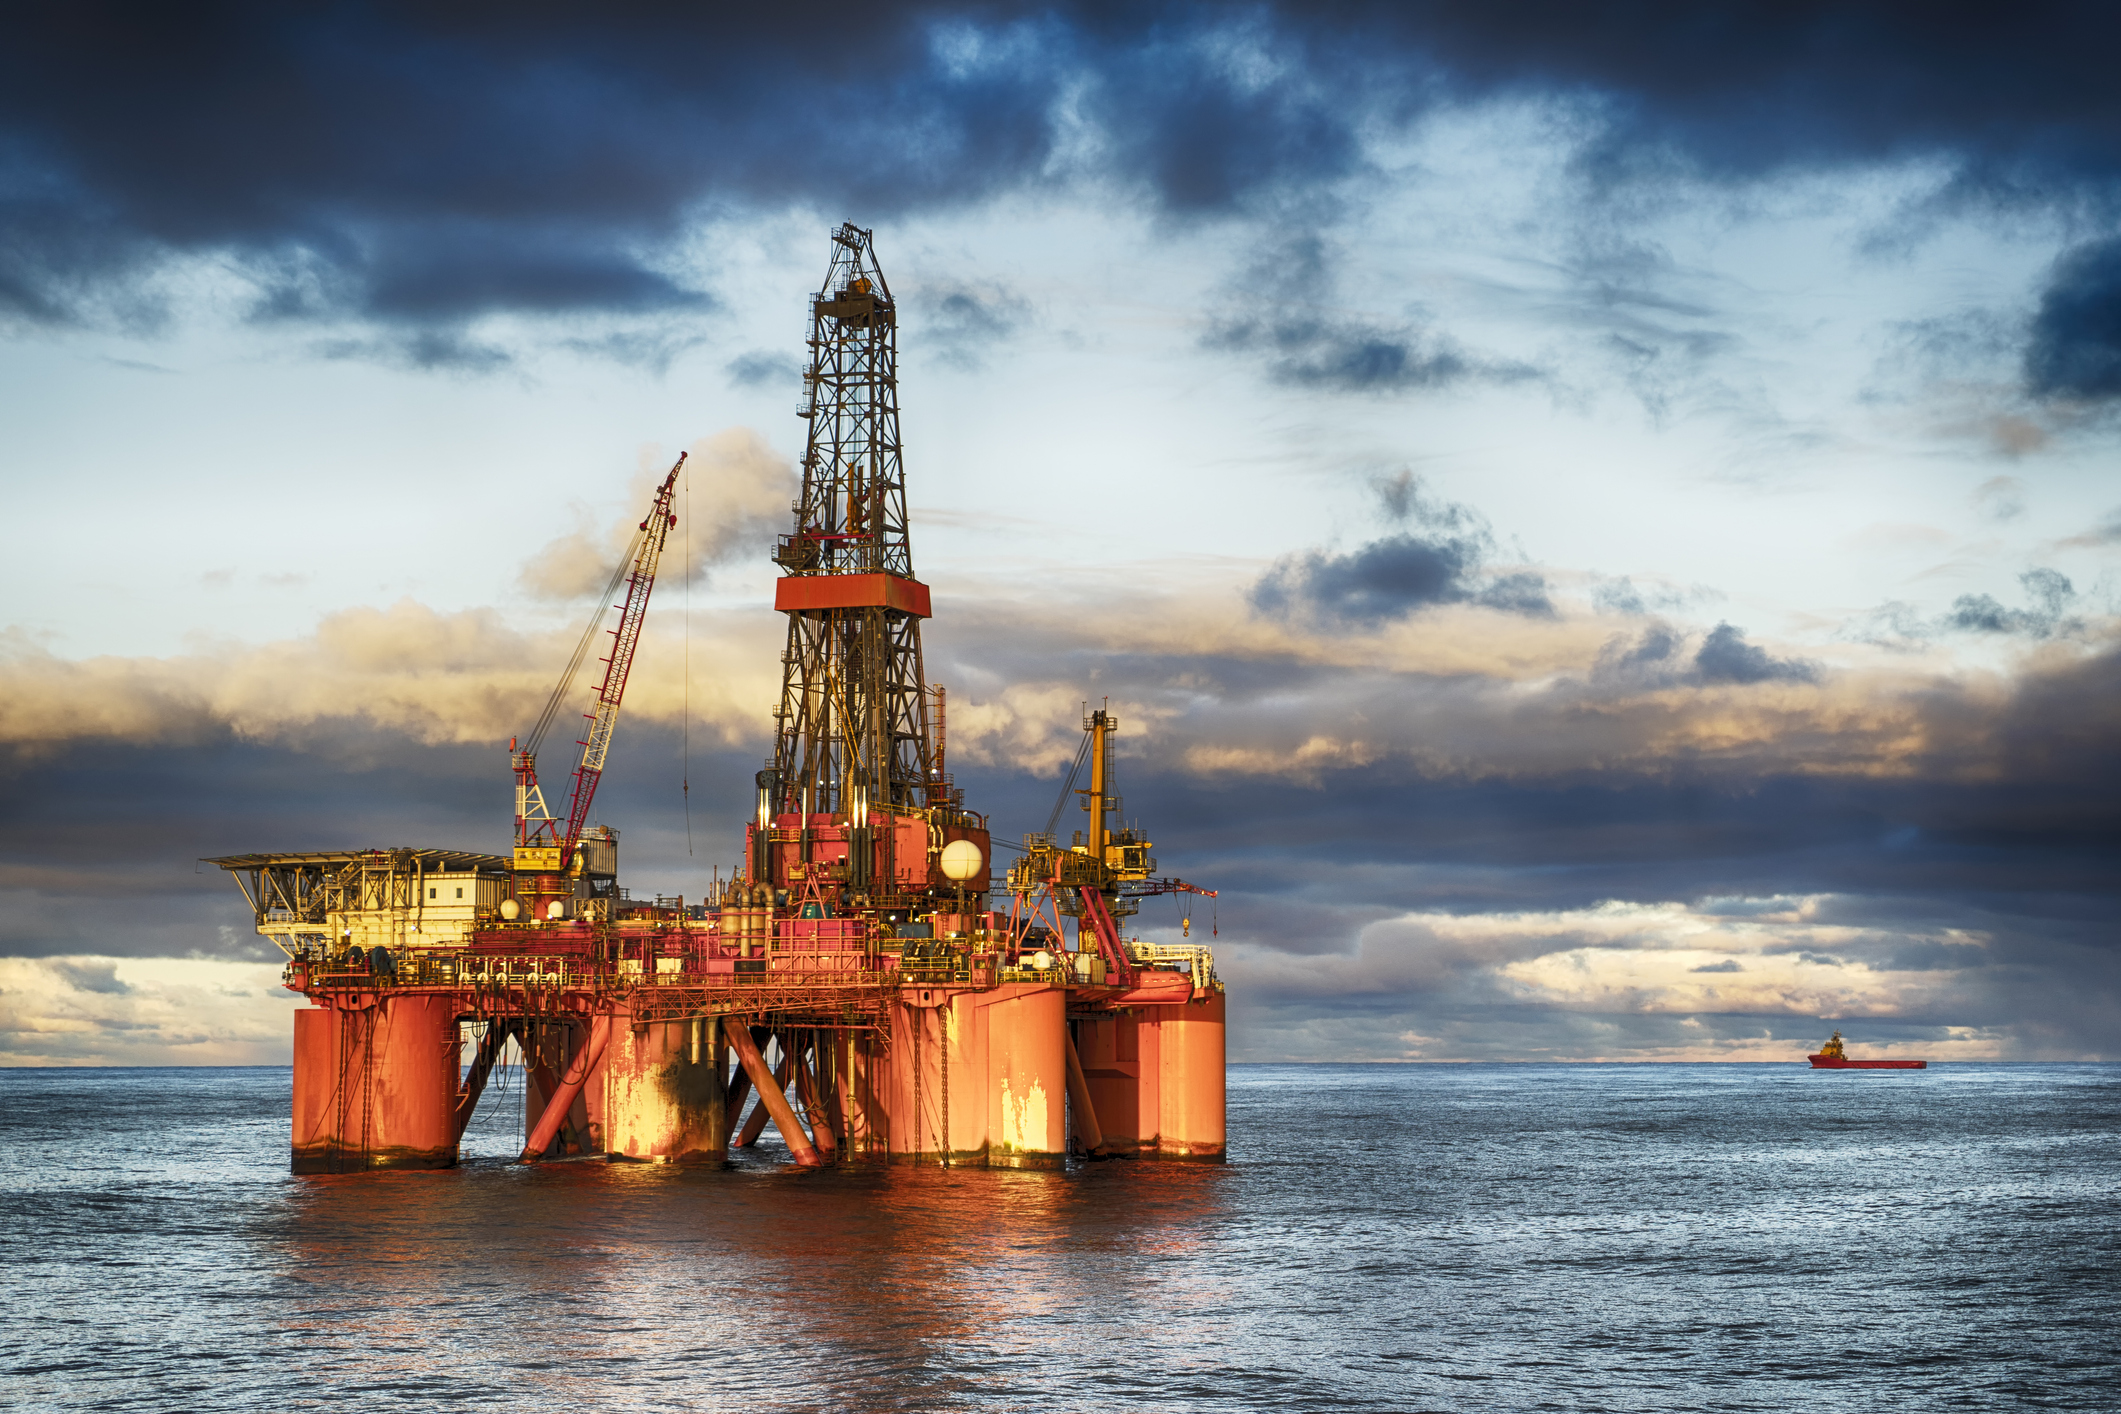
[0,1064,2121,1414]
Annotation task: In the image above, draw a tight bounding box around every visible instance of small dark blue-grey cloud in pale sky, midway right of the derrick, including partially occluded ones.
[1251,471,1555,625]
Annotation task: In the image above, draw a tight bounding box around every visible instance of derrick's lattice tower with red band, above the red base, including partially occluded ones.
[759,225,946,825]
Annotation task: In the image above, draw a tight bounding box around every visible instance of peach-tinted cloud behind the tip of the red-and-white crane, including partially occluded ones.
[522,419,802,600]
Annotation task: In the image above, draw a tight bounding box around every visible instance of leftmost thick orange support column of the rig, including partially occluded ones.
[291,996,460,1174]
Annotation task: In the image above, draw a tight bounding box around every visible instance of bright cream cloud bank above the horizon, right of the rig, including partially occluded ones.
[1217,895,2117,1062]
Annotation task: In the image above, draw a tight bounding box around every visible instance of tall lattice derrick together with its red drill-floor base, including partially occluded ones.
[747,225,988,922]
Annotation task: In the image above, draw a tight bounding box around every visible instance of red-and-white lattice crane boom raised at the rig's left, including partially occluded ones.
[509,452,685,876]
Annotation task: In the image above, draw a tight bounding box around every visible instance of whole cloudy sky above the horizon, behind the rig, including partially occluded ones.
[0,0,2121,1064]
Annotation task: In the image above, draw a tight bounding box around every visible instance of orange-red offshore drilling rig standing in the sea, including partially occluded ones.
[210,225,1224,1172]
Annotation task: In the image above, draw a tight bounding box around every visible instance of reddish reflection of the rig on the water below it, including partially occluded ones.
[263,1151,1228,1403]
